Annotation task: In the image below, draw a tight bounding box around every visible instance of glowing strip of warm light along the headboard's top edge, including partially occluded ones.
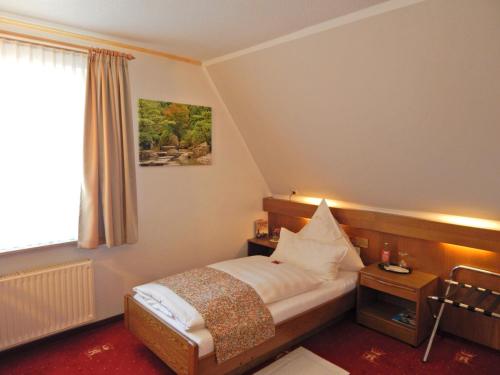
[274,195,500,231]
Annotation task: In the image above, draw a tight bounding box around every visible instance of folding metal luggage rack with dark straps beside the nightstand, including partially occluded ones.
[422,265,500,362]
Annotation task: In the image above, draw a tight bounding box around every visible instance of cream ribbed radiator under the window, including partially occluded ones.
[0,260,95,350]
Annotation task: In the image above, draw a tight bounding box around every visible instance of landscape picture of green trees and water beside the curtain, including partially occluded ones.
[139,99,212,167]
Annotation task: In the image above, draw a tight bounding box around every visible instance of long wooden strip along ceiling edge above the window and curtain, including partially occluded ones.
[0,15,201,65]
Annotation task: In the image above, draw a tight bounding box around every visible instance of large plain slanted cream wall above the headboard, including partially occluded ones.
[207,0,500,220]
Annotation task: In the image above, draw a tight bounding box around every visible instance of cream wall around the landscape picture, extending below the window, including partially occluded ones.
[0,23,269,319]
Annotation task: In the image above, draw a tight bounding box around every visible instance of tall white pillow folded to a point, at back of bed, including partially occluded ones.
[298,199,364,271]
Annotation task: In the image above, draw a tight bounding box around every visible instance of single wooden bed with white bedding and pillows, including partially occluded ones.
[125,198,363,375]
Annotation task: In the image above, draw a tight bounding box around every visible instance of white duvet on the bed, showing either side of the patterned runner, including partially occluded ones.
[134,255,322,331]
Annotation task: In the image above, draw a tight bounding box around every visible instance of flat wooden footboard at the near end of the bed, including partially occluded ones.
[125,294,198,375]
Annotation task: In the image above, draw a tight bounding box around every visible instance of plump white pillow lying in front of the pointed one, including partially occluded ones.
[271,228,348,280]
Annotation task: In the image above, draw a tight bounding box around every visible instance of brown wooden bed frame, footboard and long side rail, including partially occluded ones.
[125,290,356,375]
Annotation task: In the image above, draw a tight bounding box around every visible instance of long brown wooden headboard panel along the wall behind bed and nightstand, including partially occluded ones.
[263,198,500,349]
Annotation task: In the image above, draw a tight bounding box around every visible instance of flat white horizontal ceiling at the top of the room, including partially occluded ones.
[0,0,385,59]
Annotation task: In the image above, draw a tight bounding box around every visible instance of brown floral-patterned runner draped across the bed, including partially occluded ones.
[157,267,275,363]
